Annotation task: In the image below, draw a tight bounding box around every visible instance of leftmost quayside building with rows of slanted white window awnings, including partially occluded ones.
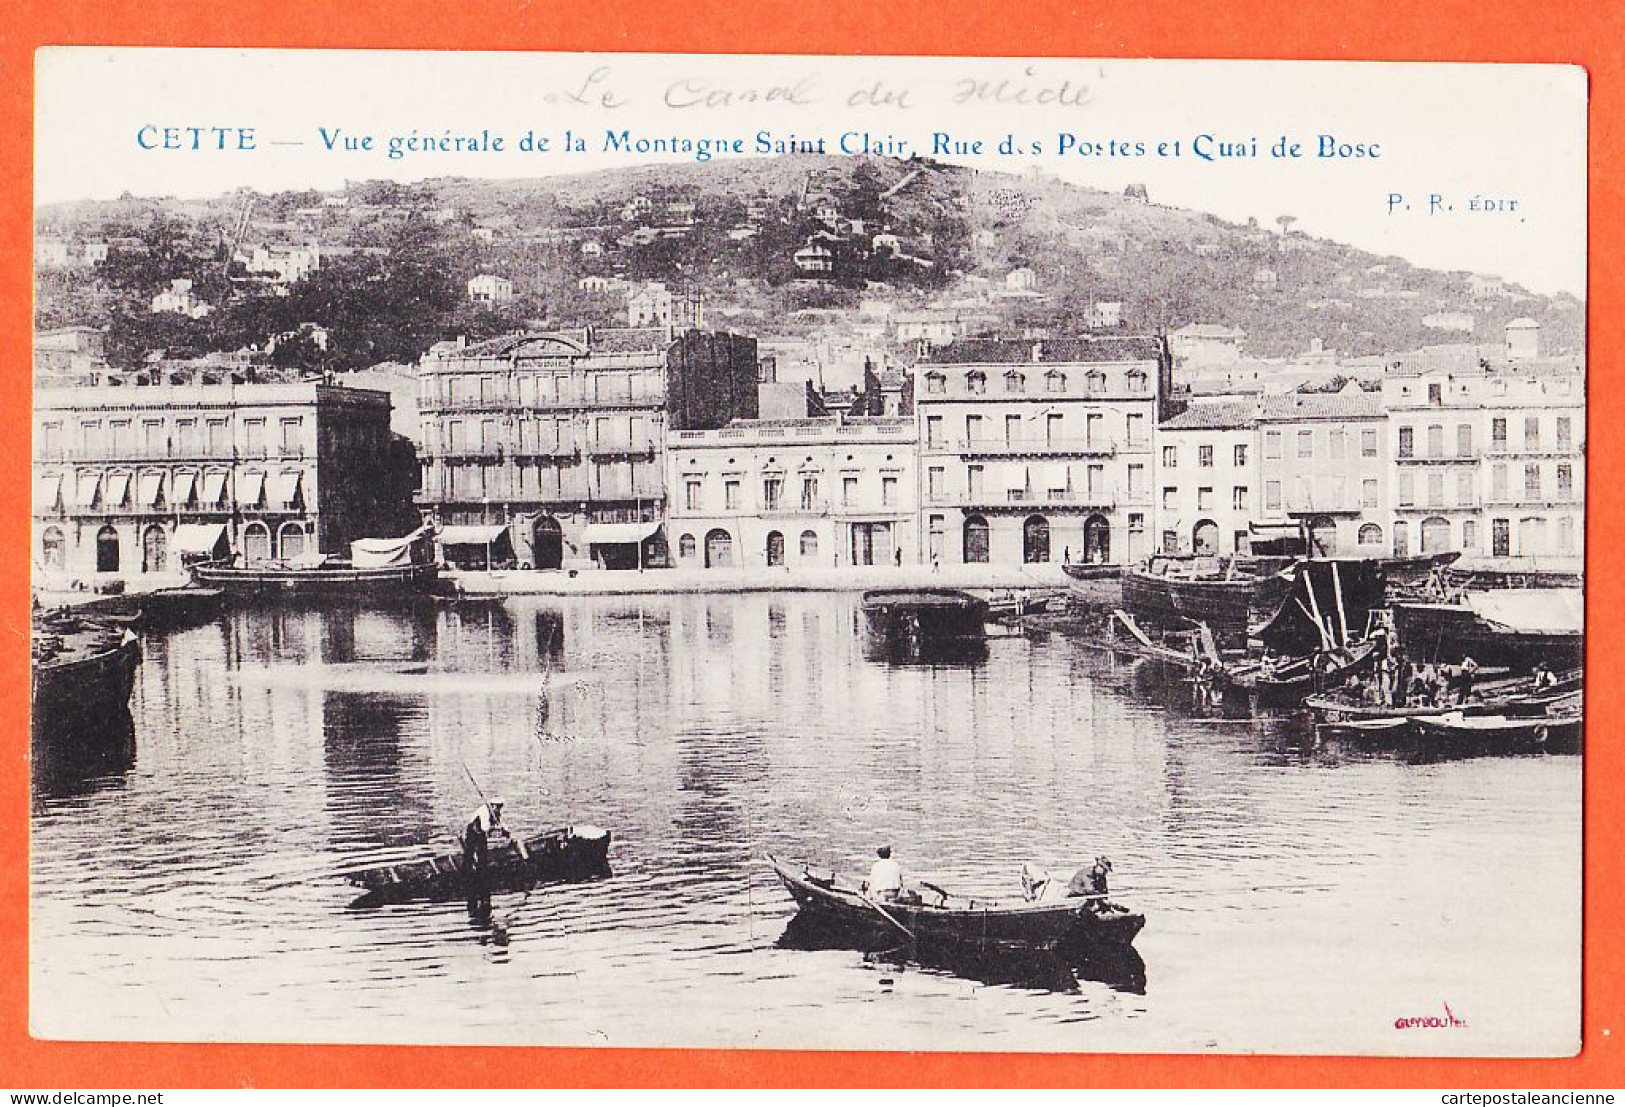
[33,382,414,575]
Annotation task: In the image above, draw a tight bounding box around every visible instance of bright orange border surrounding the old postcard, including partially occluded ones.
[0,0,1625,1089]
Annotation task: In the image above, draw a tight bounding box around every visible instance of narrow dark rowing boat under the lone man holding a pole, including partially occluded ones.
[343,826,609,907]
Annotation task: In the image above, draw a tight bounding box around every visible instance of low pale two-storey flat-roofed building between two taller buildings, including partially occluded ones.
[666,415,920,569]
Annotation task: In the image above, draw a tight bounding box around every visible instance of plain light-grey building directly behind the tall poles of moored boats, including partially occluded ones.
[1258,384,1389,558]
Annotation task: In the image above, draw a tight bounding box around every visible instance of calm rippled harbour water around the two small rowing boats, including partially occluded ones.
[31,595,1581,1055]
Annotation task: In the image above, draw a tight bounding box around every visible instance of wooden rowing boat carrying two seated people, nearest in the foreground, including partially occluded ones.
[767,855,1146,948]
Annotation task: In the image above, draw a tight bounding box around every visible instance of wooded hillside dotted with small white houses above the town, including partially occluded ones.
[36,156,1583,367]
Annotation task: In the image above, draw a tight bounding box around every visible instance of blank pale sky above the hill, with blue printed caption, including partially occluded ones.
[36,47,1586,297]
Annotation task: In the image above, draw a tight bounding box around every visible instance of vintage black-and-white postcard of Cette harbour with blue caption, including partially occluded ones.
[29,47,1588,1057]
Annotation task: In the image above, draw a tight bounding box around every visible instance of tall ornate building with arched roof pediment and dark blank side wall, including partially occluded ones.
[418,328,757,569]
